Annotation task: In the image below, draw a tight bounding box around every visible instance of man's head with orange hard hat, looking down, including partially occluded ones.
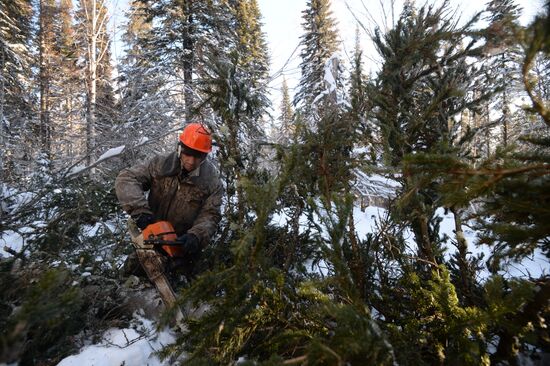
[178,123,212,172]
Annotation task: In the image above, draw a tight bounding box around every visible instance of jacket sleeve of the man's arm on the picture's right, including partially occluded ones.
[187,179,223,248]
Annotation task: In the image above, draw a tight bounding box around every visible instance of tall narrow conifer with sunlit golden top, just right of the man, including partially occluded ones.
[199,0,269,224]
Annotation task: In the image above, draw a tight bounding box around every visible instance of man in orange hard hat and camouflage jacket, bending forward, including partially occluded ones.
[115,123,223,276]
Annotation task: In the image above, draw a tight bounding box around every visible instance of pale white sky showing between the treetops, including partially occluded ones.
[111,0,543,115]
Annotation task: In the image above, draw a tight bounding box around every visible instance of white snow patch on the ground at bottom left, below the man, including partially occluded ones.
[58,315,176,366]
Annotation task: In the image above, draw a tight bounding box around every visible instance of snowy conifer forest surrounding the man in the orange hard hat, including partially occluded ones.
[0,0,550,366]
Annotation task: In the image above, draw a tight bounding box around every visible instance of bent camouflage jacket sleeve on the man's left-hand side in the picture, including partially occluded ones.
[115,159,156,216]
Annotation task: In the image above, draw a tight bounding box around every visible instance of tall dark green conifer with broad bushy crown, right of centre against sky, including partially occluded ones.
[373,2,492,274]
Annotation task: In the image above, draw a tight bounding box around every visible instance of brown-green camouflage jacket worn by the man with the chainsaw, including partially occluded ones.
[115,152,223,247]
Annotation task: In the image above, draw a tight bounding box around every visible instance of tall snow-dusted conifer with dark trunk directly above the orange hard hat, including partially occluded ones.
[145,0,234,121]
